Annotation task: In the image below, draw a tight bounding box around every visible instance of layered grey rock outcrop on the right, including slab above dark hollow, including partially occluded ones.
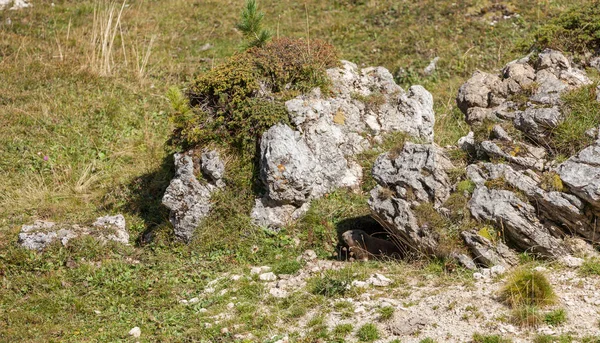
[369,50,600,267]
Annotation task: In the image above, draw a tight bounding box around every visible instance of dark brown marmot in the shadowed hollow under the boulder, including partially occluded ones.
[342,230,403,261]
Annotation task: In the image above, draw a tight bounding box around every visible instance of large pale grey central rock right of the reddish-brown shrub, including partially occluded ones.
[252,61,435,228]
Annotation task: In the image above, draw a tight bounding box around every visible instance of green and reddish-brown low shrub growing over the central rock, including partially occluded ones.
[169,38,337,154]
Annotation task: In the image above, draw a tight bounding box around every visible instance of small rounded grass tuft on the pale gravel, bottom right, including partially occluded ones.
[500,268,556,308]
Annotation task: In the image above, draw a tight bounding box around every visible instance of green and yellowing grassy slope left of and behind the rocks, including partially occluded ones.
[0,0,583,341]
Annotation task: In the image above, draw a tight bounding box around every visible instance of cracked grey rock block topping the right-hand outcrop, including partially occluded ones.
[456,49,591,126]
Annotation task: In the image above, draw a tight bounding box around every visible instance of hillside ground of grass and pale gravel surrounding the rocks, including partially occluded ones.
[0,0,600,342]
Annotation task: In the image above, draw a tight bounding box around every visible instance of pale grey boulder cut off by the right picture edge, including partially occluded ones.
[557,141,600,211]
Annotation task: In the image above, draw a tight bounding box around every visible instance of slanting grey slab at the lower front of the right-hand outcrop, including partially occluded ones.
[468,186,568,257]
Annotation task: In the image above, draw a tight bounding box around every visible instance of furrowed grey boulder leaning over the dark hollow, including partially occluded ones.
[369,142,452,255]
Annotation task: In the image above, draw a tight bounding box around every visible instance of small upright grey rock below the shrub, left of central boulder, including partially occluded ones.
[162,151,224,242]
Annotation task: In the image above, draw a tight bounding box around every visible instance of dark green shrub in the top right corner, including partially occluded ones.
[528,0,600,54]
